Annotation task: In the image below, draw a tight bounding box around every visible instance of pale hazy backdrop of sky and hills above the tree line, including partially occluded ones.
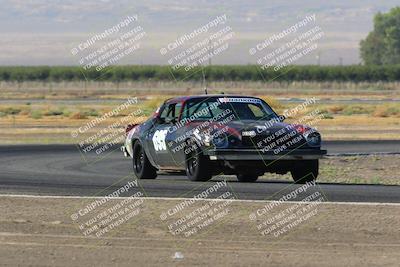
[0,0,400,65]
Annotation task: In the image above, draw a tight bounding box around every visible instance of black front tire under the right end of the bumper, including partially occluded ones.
[290,159,319,184]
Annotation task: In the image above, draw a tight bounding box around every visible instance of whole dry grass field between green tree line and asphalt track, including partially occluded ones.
[0,82,400,143]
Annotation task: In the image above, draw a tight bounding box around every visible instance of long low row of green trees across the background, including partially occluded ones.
[0,65,400,82]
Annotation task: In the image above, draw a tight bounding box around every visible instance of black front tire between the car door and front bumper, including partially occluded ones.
[185,144,212,182]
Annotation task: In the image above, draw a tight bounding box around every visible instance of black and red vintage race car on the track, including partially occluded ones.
[121,94,326,183]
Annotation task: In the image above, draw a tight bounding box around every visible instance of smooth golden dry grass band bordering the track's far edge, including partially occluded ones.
[0,115,400,144]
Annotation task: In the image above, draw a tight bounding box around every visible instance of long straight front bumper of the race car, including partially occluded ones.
[204,149,327,160]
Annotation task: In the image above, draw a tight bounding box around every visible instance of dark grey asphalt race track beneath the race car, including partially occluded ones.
[0,141,400,203]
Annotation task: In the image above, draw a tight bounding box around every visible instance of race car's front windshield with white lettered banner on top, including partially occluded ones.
[182,97,277,121]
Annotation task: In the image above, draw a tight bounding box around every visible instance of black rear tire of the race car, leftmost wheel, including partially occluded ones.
[133,141,157,179]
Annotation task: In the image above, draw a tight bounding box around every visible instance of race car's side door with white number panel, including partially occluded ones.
[147,103,181,168]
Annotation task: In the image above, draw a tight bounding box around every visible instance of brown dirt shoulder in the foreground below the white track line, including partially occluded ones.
[0,196,400,266]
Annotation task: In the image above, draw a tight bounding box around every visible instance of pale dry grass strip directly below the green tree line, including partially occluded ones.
[0,81,400,99]
